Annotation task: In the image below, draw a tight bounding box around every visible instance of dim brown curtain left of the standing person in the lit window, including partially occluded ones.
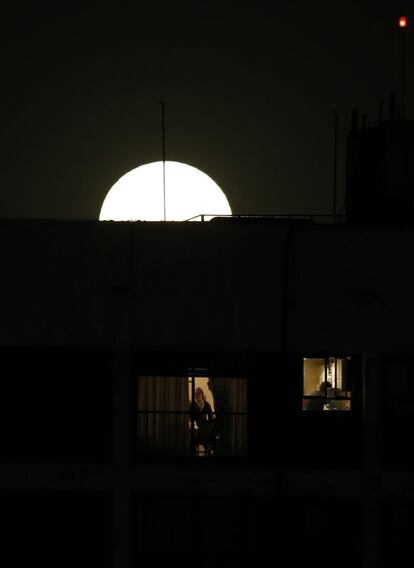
[137,376,189,456]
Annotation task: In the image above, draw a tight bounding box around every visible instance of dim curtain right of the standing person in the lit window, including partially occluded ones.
[209,377,247,457]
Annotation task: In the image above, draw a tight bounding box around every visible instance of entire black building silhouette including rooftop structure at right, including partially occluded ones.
[0,103,414,568]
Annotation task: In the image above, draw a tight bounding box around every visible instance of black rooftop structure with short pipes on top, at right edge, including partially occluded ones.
[346,93,414,226]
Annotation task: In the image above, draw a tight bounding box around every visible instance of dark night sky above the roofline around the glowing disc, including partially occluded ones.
[0,0,414,219]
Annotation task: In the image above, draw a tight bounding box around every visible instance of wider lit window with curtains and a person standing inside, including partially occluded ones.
[137,368,247,457]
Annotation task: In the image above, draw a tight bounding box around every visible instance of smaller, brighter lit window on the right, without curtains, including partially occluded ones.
[302,357,352,411]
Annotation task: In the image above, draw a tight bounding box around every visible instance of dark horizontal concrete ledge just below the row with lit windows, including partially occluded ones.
[0,462,414,500]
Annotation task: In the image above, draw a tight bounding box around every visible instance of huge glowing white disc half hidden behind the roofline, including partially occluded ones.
[99,162,232,221]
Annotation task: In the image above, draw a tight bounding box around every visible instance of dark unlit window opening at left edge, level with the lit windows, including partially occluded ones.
[0,347,113,463]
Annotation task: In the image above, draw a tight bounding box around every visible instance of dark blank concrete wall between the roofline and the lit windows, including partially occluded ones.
[0,220,414,352]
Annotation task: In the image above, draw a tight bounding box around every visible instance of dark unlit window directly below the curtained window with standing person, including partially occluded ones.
[133,495,254,568]
